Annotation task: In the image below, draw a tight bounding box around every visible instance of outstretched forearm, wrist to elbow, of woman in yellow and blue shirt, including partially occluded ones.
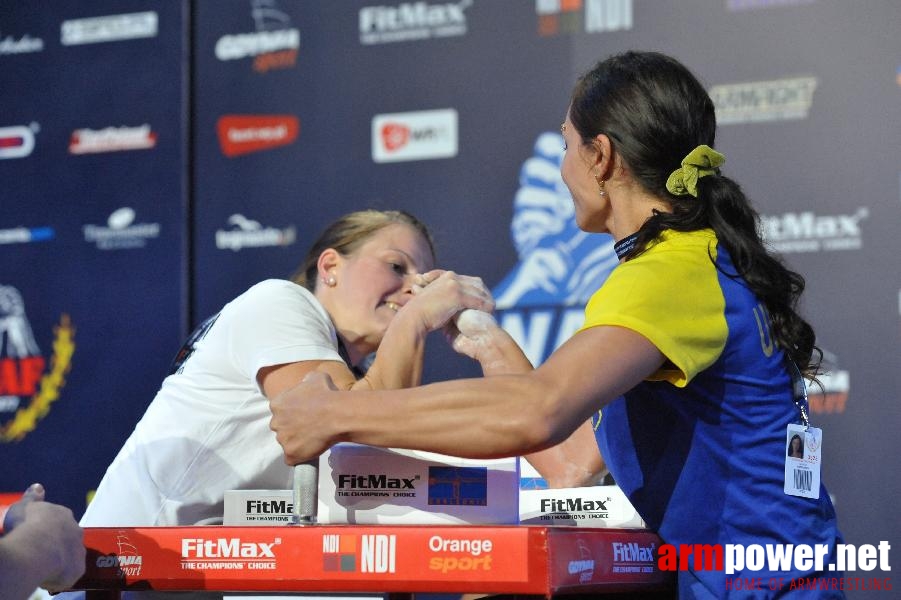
[298,375,584,458]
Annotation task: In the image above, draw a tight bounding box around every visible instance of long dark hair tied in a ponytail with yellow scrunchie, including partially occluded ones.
[569,52,822,379]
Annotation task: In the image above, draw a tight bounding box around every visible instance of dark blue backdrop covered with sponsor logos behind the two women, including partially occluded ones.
[0,0,901,597]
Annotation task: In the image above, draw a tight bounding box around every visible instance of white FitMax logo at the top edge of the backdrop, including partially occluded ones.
[359,0,472,45]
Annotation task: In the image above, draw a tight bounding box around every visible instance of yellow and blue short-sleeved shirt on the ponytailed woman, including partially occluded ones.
[582,230,843,598]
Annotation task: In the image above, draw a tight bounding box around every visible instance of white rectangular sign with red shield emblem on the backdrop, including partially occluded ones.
[372,108,458,163]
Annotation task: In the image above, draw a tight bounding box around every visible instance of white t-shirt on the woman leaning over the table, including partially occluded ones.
[81,279,342,527]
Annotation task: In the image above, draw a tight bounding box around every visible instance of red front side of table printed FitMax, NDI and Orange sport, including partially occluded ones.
[79,526,546,592]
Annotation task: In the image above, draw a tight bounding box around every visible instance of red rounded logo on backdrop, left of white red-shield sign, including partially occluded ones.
[216,115,300,158]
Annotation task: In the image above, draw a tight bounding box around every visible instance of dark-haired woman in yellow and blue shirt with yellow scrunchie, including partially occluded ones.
[272,52,842,598]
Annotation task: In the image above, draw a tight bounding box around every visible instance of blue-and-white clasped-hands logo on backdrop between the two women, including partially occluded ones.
[492,132,619,366]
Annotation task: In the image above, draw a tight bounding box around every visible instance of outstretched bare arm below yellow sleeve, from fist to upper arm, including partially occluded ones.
[271,327,664,464]
